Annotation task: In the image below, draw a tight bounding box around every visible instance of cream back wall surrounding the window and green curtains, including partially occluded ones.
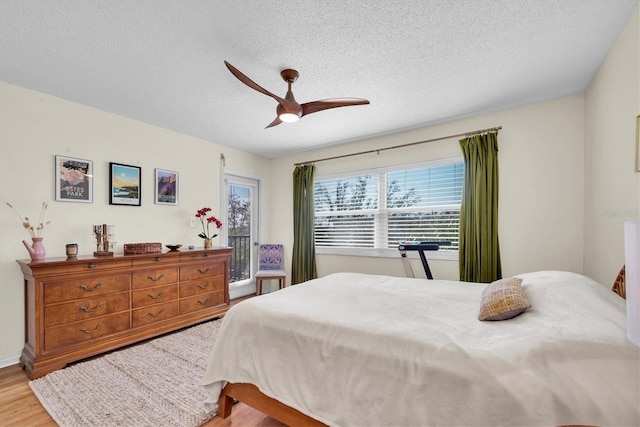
[271,96,584,280]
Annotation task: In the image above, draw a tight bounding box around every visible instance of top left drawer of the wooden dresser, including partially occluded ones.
[44,274,131,304]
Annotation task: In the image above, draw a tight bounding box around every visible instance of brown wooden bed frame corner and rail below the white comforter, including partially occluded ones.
[218,383,326,427]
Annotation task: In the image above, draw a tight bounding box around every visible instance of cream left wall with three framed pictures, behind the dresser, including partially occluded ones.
[0,82,269,366]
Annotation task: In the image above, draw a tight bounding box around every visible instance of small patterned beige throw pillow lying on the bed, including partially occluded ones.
[478,277,531,320]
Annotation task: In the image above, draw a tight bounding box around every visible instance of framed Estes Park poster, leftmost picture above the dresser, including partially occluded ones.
[56,156,93,203]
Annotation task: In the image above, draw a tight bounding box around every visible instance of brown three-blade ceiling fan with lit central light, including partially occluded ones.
[224,61,369,129]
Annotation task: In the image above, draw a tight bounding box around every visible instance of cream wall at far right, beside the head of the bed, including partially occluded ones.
[584,6,640,286]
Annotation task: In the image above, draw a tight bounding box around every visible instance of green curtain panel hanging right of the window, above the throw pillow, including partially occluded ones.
[458,133,502,283]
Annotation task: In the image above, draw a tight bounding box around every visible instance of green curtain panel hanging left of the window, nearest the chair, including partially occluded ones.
[291,165,318,285]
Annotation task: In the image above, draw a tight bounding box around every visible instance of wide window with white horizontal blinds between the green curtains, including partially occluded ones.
[315,158,464,258]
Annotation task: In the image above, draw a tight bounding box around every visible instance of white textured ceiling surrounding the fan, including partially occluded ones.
[0,0,638,157]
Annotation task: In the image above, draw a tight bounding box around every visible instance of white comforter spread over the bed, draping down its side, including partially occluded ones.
[203,272,640,426]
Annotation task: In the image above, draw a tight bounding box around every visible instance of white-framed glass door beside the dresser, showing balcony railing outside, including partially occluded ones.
[225,174,259,293]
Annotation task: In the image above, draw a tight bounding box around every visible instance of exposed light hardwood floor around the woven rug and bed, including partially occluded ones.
[0,297,284,427]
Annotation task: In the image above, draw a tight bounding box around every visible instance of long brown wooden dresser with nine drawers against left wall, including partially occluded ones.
[18,248,231,379]
